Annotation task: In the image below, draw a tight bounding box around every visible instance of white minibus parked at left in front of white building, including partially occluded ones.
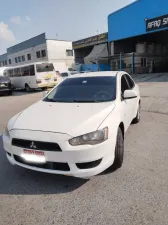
[4,62,57,92]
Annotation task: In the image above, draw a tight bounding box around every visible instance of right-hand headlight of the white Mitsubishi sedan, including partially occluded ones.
[69,127,108,146]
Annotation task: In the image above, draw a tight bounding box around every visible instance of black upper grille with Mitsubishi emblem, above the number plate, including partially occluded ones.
[12,138,62,152]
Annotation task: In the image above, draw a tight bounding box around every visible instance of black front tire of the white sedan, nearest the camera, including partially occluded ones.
[112,127,124,169]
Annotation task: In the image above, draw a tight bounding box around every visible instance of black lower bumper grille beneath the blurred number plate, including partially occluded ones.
[13,155,70,171]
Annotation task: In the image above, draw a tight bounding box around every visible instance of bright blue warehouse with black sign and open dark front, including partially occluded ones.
[108,0,168,73]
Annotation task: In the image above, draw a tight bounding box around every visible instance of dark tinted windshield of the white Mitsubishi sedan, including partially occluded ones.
[44,77,116,102]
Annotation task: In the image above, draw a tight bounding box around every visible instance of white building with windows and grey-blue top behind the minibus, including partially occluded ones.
[0,33,74,71]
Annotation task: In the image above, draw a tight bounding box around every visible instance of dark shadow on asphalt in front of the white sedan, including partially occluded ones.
[0,137,87,195]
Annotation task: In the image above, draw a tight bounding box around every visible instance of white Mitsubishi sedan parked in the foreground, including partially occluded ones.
[3,71,140,178]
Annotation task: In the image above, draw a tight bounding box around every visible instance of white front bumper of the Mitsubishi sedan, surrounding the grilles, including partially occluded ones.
[3,131,115,178]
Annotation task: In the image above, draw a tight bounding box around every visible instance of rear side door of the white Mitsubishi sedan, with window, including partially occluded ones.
[125,74,139,118]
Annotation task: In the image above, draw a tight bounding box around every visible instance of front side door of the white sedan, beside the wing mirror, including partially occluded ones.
[120,74,133,130]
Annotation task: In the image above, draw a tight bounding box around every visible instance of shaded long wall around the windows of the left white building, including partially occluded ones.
[7,43,48,66]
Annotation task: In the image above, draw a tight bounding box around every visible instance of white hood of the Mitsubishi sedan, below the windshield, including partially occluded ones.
[12,101,115,137]
